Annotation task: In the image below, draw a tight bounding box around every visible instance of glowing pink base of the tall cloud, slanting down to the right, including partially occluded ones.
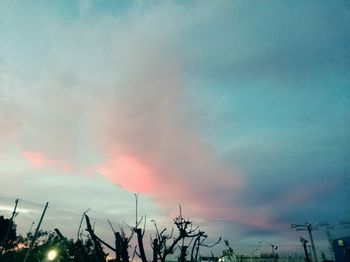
[96,149,247,227]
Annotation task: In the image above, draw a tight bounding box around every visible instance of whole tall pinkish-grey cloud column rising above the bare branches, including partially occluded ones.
[84,25,250,225]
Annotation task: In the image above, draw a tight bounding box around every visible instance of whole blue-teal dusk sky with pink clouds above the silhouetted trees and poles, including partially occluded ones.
[0,0,350,258]
